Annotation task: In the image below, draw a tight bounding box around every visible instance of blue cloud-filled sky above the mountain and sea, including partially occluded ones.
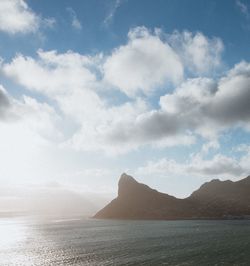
[0,0,250,215]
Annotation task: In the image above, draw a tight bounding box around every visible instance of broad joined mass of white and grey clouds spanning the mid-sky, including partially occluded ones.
[2,27,250,154]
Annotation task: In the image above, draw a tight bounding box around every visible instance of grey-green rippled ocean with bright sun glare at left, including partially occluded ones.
[0,217,250,266]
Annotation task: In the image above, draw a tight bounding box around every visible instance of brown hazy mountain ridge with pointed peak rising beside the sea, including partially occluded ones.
[94,173,250,220]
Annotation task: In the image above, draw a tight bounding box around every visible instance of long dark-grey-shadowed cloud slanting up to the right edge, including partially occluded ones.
[105,62,250,147]
